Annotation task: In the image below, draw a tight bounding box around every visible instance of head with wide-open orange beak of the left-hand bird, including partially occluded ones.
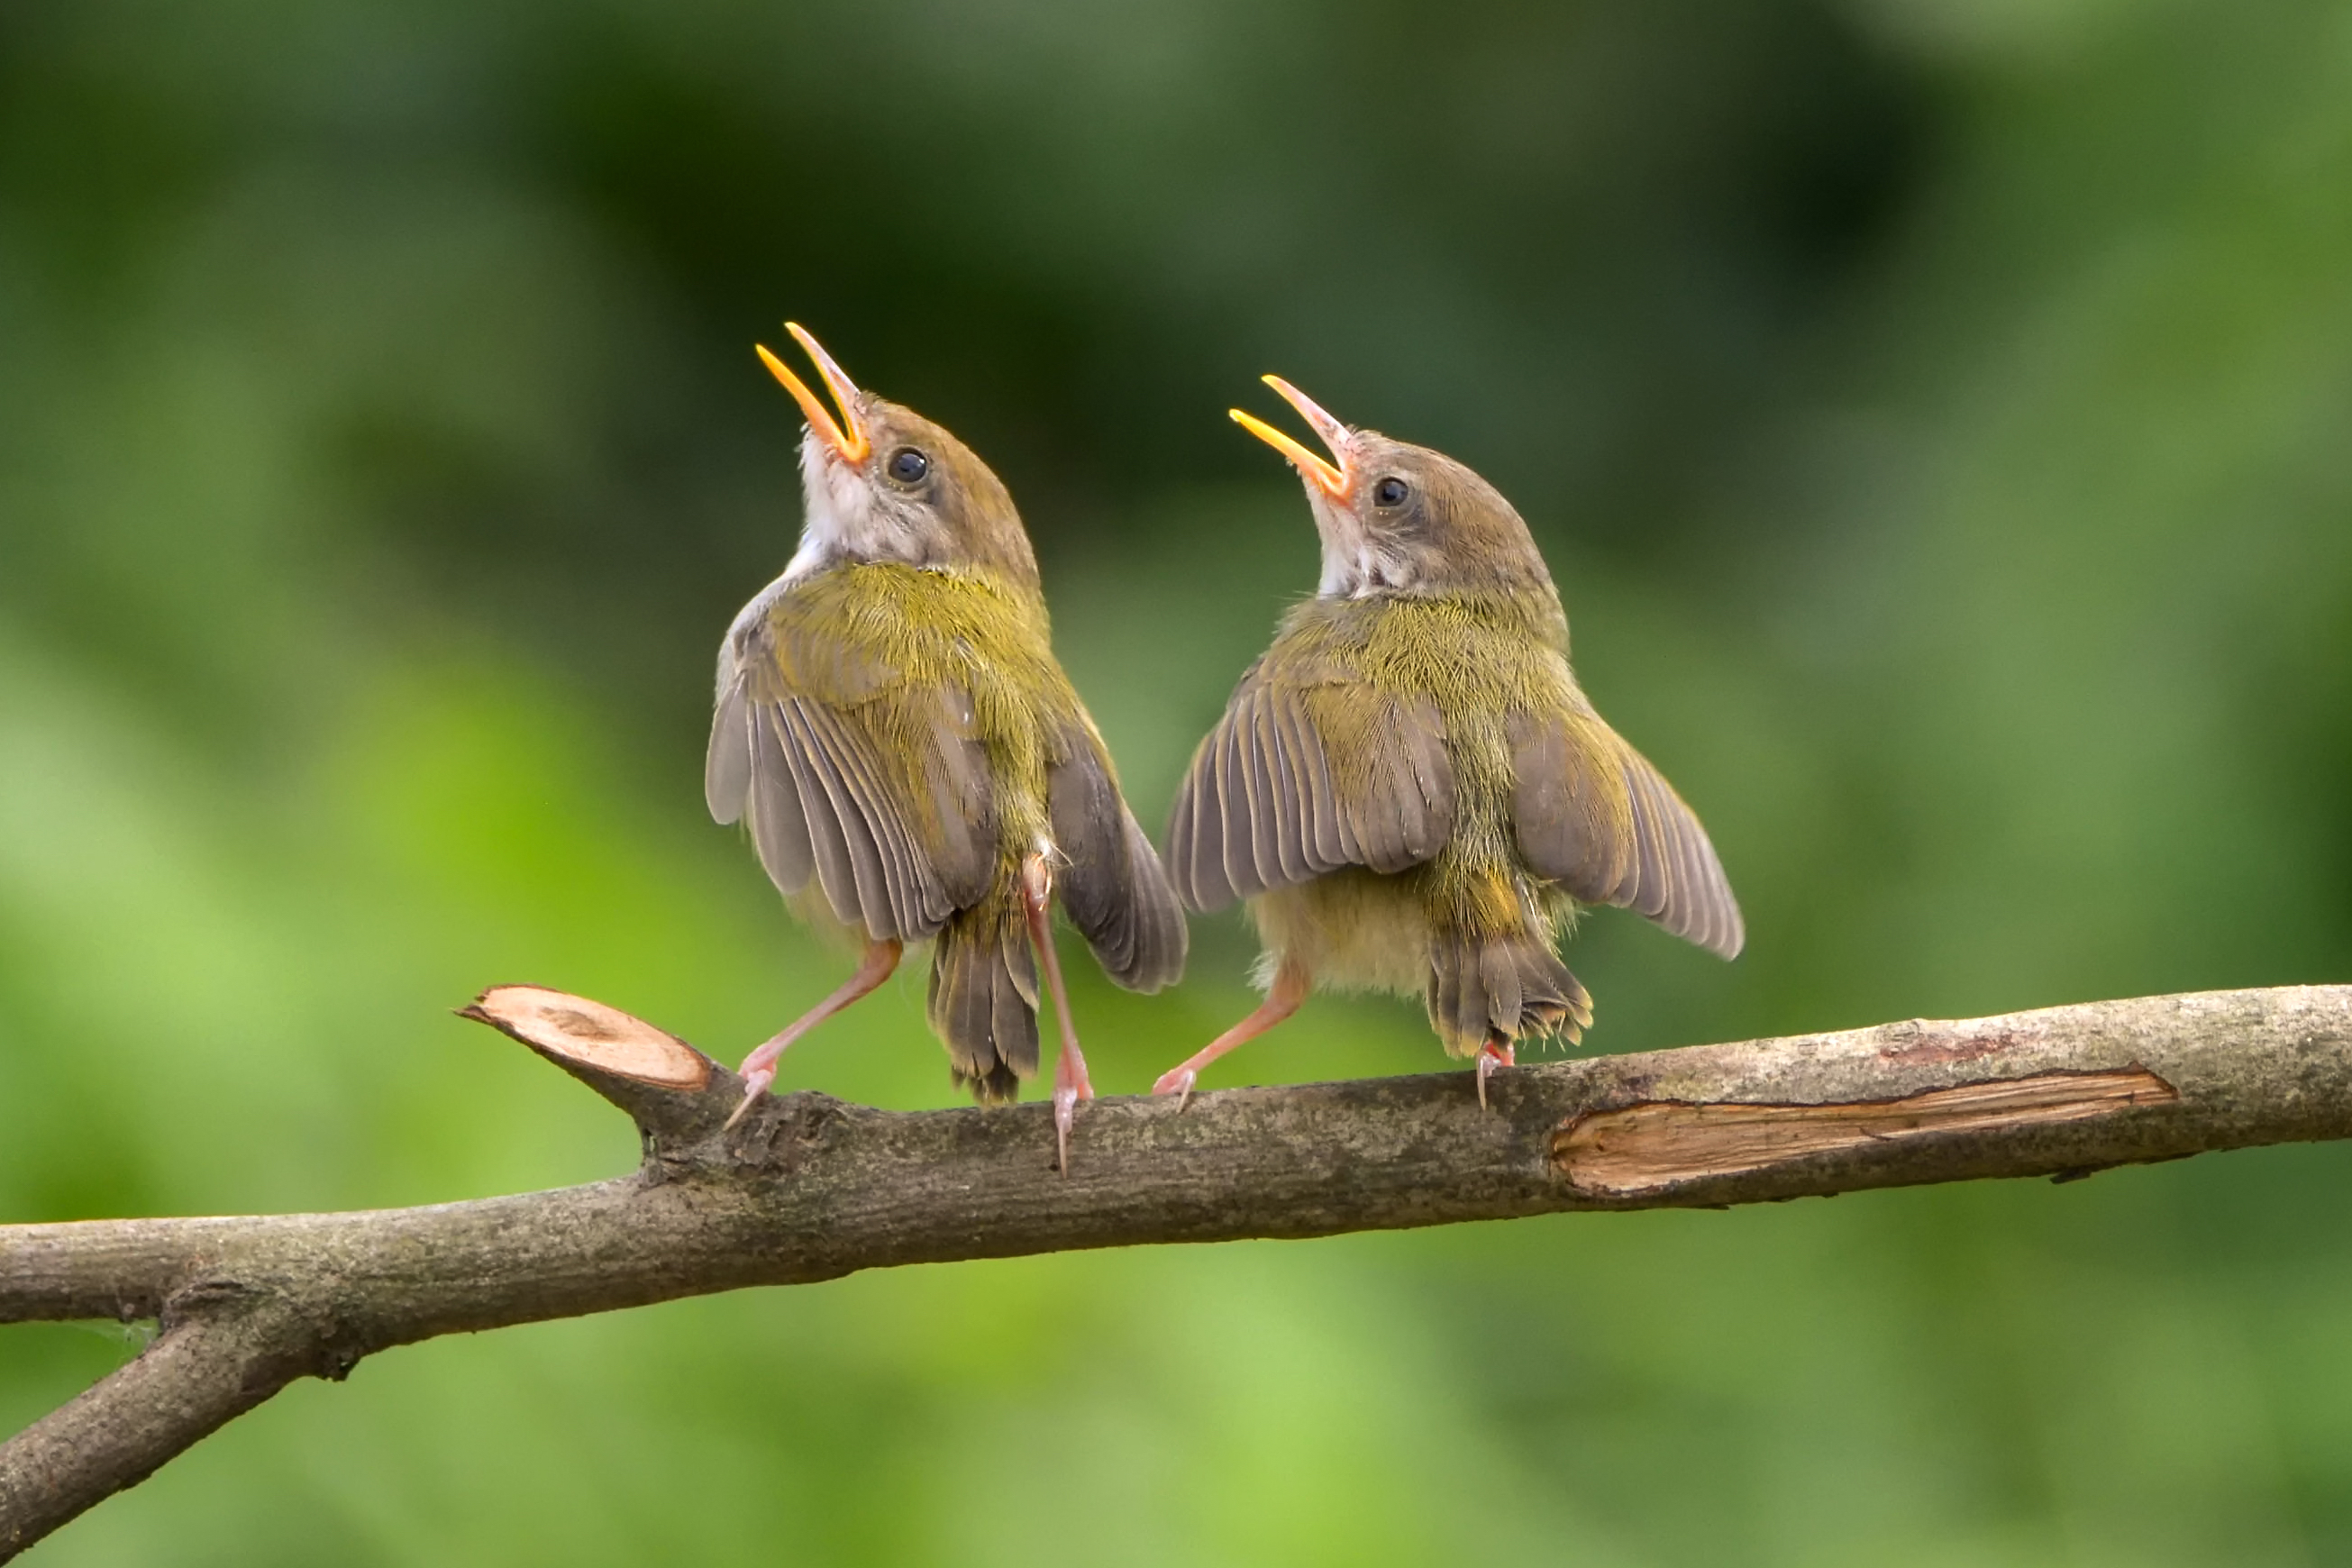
[760,322,1037,590]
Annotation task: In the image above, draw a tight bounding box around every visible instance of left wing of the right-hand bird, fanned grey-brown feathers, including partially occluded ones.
[1169,658,1454,910]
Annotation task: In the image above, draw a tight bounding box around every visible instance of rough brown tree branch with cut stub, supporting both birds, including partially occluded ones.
[0,988,2352,1559]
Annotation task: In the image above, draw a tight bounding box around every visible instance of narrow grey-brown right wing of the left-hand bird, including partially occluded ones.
[1046,722,1188,992]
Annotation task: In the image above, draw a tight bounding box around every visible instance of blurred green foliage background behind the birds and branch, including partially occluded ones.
[0,0,2352,1568]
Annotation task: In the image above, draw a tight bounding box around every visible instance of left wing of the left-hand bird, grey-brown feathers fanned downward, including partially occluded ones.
[703,628,995,940]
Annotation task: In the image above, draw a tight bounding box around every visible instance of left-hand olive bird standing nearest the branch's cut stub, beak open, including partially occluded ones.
[703,322,1185,1169]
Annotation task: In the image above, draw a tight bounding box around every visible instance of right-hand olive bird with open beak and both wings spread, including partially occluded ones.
[1153,376,1746,1102]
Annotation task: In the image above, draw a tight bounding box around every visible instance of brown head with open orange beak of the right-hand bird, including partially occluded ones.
[1233,376,1553,597]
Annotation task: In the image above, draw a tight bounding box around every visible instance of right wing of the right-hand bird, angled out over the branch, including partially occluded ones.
[1510,707,1747,959]
